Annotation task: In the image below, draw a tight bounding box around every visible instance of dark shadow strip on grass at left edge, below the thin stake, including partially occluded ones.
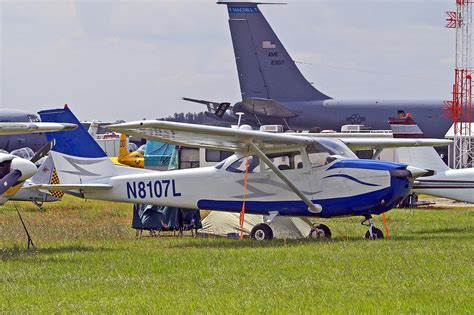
[0,245,112,261]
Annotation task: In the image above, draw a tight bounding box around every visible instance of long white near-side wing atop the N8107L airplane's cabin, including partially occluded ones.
[106,120,315,153]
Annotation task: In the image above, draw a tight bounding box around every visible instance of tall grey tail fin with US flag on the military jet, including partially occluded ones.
[218,1,330,101]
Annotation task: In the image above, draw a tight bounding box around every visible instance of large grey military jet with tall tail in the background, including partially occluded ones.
[184,1,452,138]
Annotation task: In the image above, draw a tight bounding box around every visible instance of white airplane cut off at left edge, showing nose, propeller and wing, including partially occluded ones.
[0,122,77,205]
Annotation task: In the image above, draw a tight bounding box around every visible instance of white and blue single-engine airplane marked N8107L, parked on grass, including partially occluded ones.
[32,108,425,239]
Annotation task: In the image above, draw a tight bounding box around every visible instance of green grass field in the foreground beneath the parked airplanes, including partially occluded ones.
[0,198,474,314]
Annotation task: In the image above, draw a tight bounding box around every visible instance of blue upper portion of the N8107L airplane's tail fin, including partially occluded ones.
[38,106,107,158]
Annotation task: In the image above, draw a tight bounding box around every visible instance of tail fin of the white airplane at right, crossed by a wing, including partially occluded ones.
[389,115,449,171]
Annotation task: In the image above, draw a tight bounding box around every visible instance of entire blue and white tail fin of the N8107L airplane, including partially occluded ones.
[39,106,115,184]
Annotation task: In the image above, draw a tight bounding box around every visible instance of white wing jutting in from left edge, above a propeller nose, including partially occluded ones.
[0,122,77,136]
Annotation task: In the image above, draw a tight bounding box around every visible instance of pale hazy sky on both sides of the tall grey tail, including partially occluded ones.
[0,0,455,121]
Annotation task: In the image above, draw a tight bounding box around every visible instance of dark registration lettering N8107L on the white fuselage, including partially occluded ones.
[127,179,181,199]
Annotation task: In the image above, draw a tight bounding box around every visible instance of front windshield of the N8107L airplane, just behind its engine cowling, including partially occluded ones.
[306,139,357,167]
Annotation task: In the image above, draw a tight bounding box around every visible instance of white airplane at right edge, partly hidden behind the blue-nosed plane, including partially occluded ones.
[389,115,474,203]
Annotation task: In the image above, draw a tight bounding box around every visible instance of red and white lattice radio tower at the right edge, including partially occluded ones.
[445,0,474,169]
